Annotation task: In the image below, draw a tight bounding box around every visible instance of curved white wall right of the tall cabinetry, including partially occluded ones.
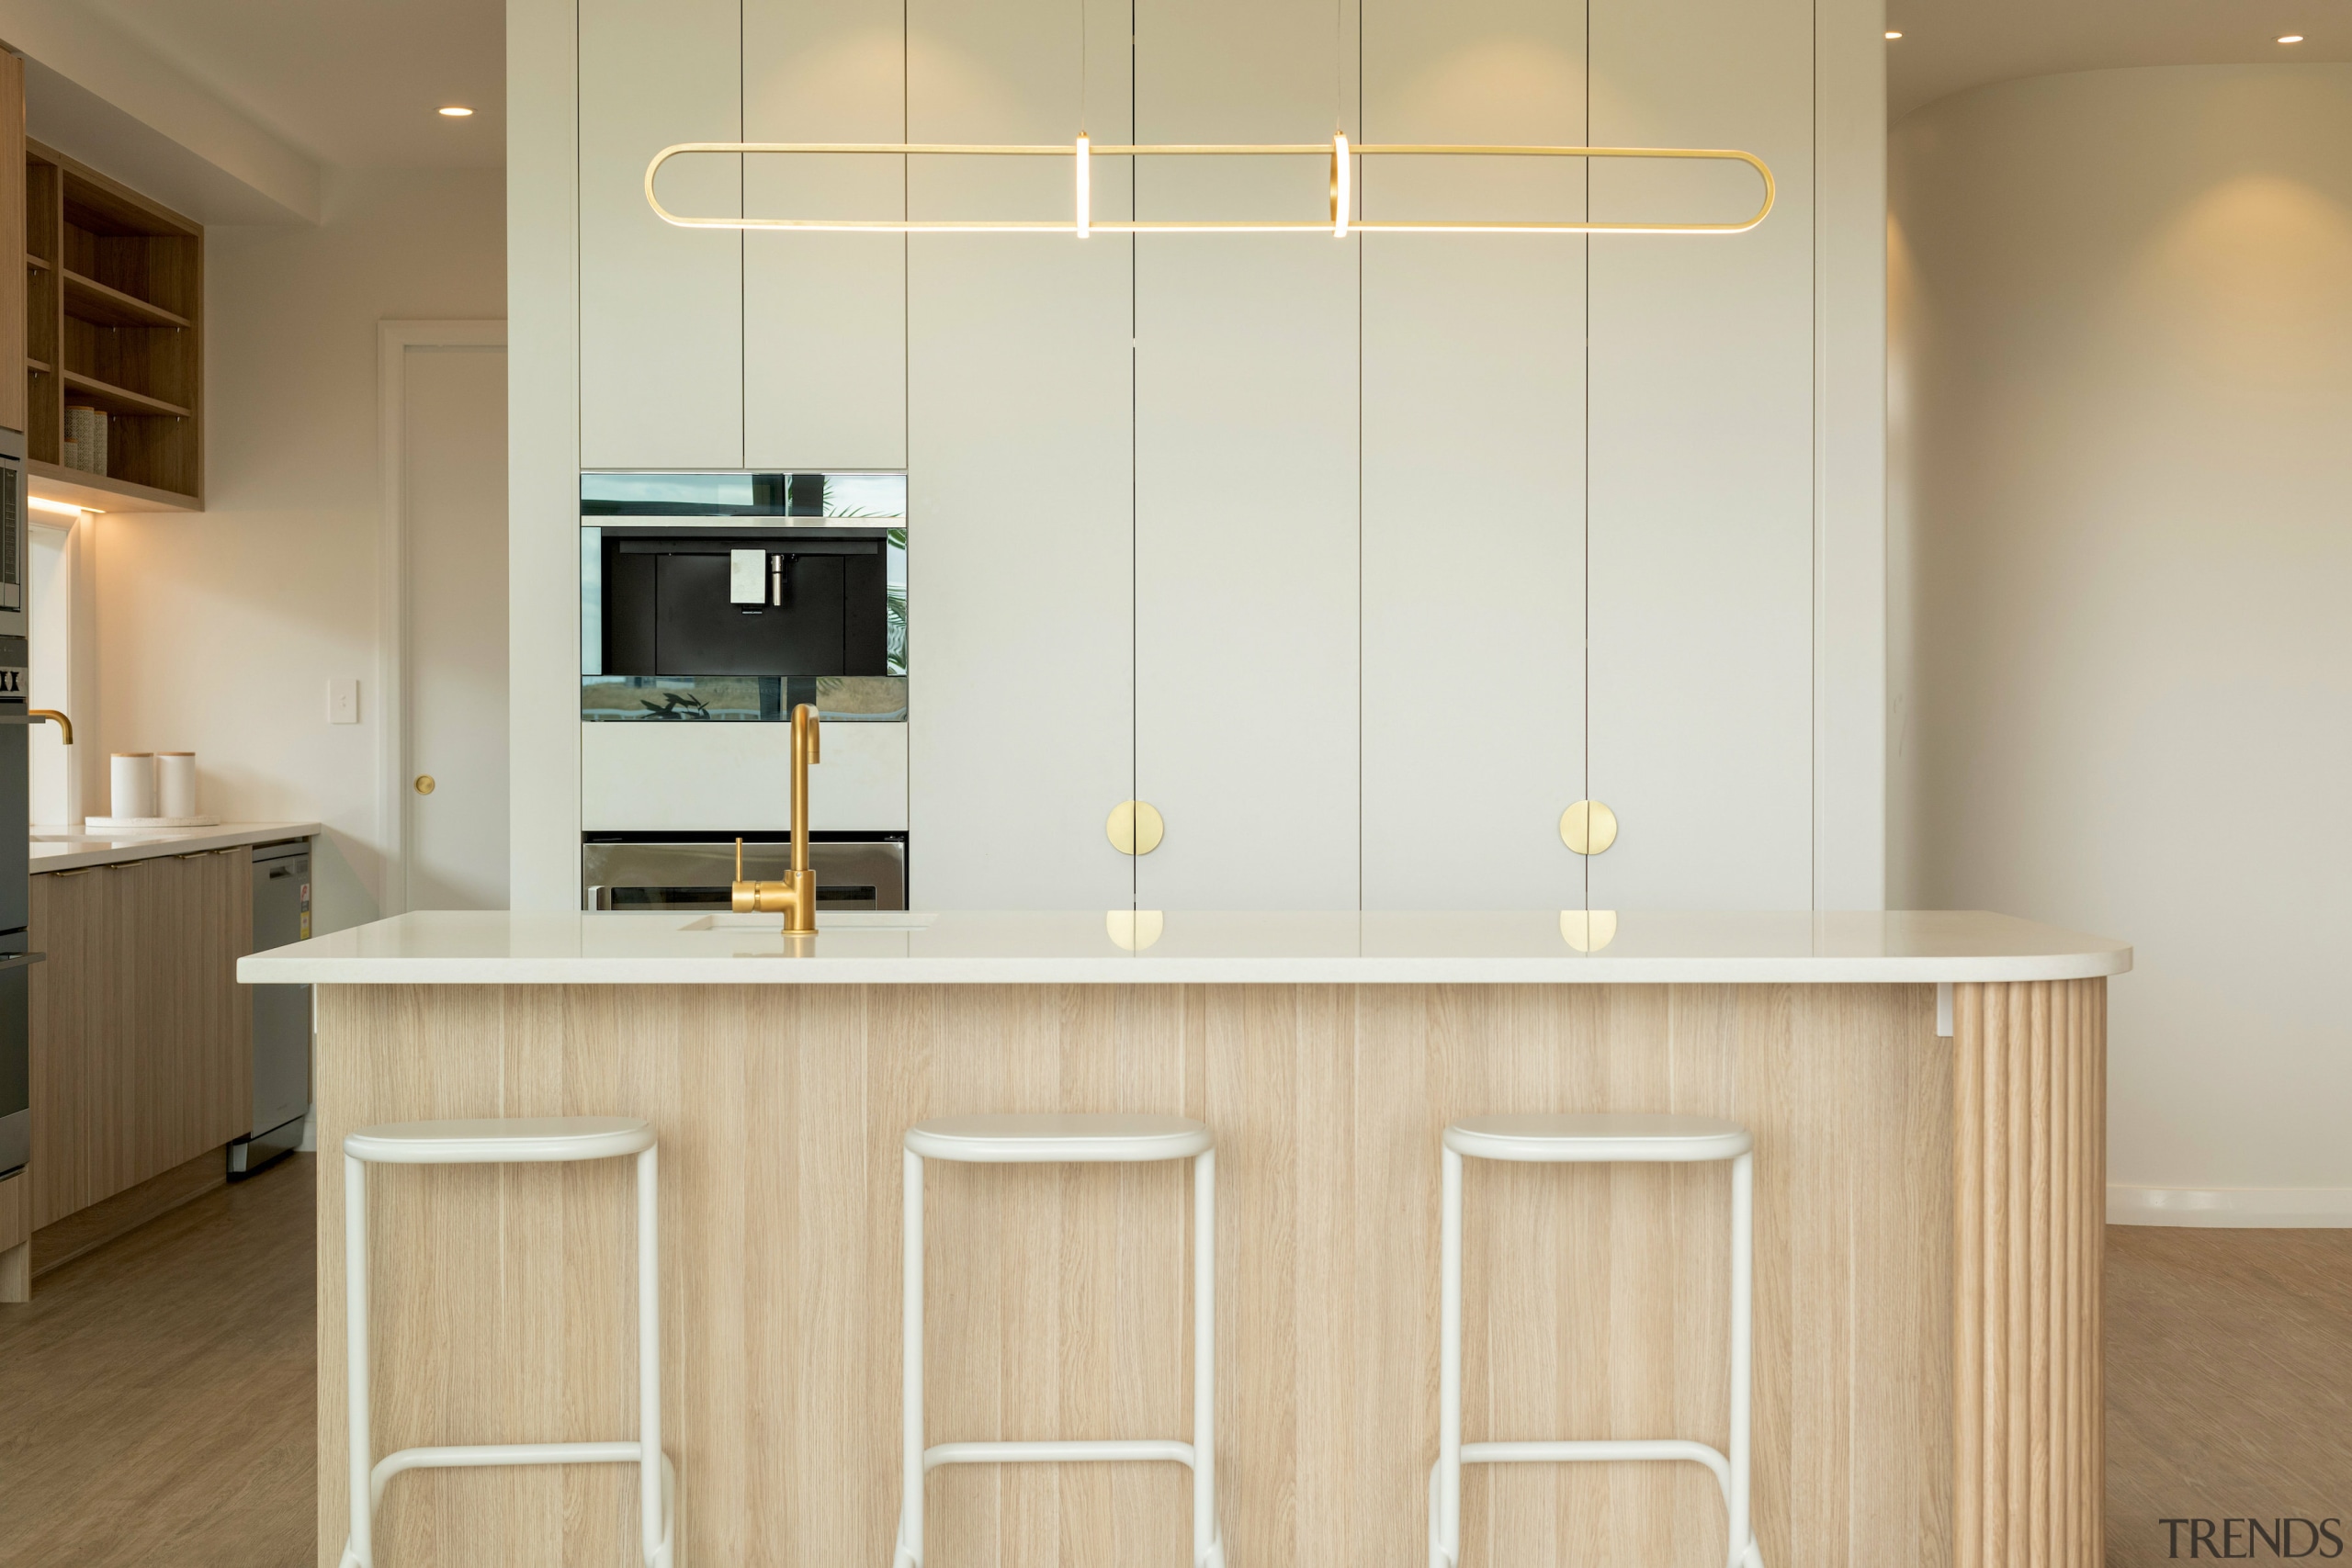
[1891,66,2352,1223]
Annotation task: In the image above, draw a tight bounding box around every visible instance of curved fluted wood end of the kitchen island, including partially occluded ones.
[1952,980,2108,1568]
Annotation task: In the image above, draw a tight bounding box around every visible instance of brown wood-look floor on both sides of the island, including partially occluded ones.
[0,1155,2352,1568]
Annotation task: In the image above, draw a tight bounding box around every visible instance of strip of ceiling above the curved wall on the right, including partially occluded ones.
[1886,0,2352,120]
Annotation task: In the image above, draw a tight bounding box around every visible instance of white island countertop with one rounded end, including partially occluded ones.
[238,909,2131,985]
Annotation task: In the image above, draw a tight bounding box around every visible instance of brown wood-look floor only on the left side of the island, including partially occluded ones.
[0,1155,318,1568]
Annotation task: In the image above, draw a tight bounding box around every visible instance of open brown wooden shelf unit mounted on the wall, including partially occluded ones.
[24,141,205,513]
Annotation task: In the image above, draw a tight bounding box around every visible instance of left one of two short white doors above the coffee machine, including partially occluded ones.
[579,0,743,468]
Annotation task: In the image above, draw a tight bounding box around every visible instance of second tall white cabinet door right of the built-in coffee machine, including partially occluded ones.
[1136,0,1360,909]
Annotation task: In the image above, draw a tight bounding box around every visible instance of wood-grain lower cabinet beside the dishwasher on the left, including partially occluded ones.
[28,846,254,1227]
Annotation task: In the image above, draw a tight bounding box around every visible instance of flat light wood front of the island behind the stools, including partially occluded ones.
[318,985,1952,1568]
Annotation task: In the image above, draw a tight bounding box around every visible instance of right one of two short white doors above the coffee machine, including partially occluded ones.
[743,0,908,470]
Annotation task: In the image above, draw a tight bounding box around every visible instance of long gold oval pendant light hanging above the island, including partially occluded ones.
[644,136,1776,237]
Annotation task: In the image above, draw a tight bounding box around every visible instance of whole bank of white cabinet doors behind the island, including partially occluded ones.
[550,0,1877,909]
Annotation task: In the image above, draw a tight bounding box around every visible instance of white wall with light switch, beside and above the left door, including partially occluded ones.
[91,169,505,931]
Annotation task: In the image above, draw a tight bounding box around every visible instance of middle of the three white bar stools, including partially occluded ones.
[891,1117,1226,1568]
